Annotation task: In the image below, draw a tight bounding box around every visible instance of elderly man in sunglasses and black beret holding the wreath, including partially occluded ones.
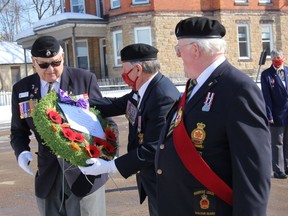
[11,36,115,216]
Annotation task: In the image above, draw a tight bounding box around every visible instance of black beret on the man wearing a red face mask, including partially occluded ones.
[120,43,158,62]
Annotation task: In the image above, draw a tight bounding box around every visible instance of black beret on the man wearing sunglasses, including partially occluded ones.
[31,36,60,58]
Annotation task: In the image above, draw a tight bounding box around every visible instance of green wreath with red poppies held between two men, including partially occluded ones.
[33,92,117,166]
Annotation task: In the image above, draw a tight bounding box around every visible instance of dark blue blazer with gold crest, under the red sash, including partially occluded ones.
[155,61,271,216]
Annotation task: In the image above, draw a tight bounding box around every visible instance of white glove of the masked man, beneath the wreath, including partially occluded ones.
[78,158,118,176]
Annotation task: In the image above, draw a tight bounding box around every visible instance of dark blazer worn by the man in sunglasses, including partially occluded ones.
[11,67,112,198]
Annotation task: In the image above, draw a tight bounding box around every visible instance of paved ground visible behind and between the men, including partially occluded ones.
[0,116,288,216]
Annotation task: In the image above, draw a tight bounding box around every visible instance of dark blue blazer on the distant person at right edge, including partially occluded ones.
[261,65,288,126]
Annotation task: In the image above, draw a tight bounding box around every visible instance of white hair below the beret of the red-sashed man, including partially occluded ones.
[190,38,227,55]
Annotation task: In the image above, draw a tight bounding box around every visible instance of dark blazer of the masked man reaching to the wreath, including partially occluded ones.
[90,72,180,203]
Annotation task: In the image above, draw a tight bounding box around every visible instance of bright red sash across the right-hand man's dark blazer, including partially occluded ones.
[173,81,232,206]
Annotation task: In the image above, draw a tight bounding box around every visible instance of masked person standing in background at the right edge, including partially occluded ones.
[261,49,288,179]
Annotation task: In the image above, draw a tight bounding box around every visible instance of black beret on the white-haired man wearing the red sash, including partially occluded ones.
[175,17,226,39]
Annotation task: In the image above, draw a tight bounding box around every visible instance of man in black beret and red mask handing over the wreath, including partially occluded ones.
[80,44,180,216]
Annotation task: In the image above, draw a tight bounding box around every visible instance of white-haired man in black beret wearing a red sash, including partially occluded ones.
[155,17,271,216]
